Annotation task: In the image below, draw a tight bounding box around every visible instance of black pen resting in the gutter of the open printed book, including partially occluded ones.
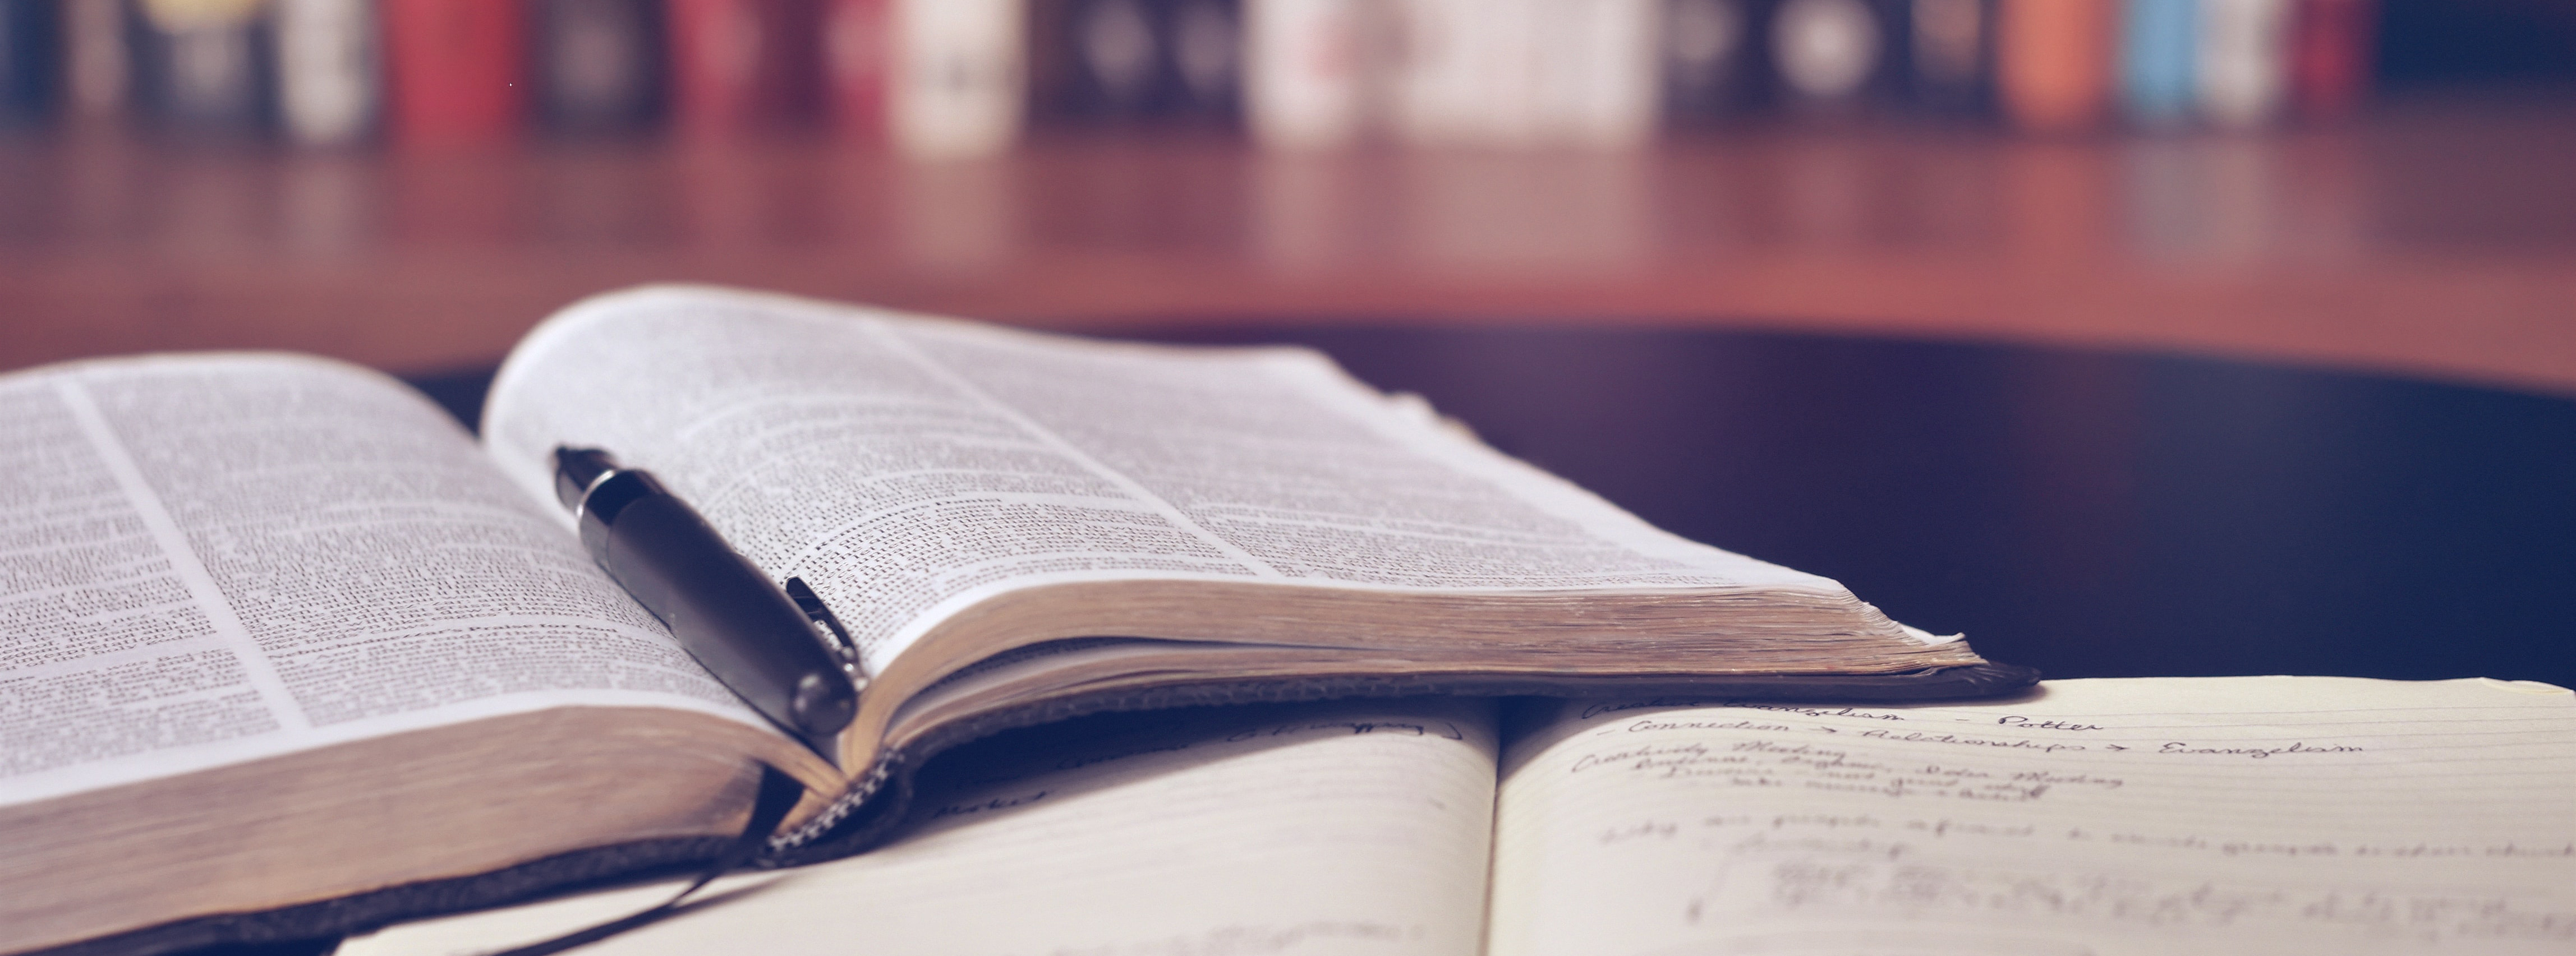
[554,449,861,742]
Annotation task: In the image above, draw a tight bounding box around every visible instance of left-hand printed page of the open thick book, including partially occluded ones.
[0,355,765,804]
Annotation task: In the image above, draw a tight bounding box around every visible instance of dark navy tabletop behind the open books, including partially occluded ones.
[196,325,2576,956]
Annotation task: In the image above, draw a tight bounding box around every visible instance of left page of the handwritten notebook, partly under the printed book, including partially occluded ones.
[340,701,1494,956]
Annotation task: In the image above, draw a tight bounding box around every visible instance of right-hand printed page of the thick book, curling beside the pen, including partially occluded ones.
[484,286,1898,670]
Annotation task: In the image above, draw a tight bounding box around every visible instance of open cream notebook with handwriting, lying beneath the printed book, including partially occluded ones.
[340,678,2576,956]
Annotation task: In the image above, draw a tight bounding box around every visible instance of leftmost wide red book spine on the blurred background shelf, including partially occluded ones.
[384,0,528,142]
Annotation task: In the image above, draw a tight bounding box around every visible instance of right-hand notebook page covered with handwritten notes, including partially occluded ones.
[1492,678,2576,956]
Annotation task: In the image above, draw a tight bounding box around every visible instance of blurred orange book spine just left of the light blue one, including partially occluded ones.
[1994,0,2118,131]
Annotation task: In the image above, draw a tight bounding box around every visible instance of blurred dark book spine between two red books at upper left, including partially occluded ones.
[531,0,667,134]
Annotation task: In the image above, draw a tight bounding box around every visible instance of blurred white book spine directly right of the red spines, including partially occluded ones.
[886,0,1028,160]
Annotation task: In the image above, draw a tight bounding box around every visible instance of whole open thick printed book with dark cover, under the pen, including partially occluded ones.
[0,289,2035,953]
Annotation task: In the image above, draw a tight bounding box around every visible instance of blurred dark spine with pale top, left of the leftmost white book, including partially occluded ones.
[129,0,270,134]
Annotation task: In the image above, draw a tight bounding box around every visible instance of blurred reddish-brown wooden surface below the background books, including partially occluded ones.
[0,98,2576,394]
